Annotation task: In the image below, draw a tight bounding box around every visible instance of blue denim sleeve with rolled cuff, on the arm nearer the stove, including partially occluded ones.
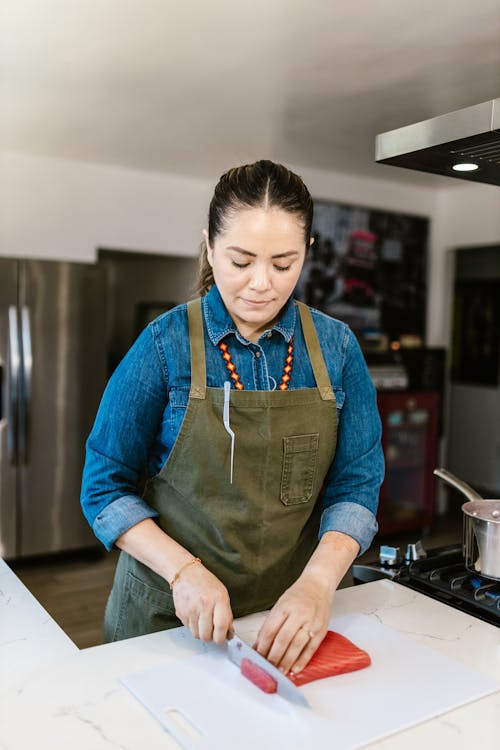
[319,329,384,555]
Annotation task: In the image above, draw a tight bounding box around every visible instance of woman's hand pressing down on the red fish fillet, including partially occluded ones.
[254,574,334,674]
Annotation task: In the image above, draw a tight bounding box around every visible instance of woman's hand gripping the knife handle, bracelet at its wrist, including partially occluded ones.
[173,563,233,643]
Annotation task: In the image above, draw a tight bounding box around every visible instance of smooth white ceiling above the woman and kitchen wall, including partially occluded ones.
[0,0,500,185]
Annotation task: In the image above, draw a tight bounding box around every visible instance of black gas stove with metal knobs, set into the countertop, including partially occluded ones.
[352,542,500,627]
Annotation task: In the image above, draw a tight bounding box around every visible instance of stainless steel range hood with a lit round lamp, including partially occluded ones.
[375,99,500,185]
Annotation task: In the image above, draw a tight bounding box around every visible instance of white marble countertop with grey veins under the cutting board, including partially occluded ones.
[0,561,500,750]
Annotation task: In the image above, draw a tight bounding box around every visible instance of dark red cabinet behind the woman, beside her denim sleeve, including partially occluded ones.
[377,391,440,534]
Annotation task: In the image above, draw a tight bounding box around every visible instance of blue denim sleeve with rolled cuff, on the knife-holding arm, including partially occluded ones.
[81,326,168,550]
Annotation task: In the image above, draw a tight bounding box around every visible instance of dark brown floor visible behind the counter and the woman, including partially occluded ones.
[9,505,462,648]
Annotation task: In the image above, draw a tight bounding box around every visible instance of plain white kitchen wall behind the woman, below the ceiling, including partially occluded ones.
[0,151,500,346]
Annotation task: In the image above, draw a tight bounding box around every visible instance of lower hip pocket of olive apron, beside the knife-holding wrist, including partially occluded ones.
[110,570,182,641]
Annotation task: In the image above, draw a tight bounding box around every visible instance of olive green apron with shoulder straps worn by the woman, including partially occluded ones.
[105,299,337,640]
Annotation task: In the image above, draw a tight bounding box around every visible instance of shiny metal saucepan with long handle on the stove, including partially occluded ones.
[434,469,500,581]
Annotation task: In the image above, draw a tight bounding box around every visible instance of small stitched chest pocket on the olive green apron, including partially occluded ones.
[280,432,319,505]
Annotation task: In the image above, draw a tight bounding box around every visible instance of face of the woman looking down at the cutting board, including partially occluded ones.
[204,208,305,341]
